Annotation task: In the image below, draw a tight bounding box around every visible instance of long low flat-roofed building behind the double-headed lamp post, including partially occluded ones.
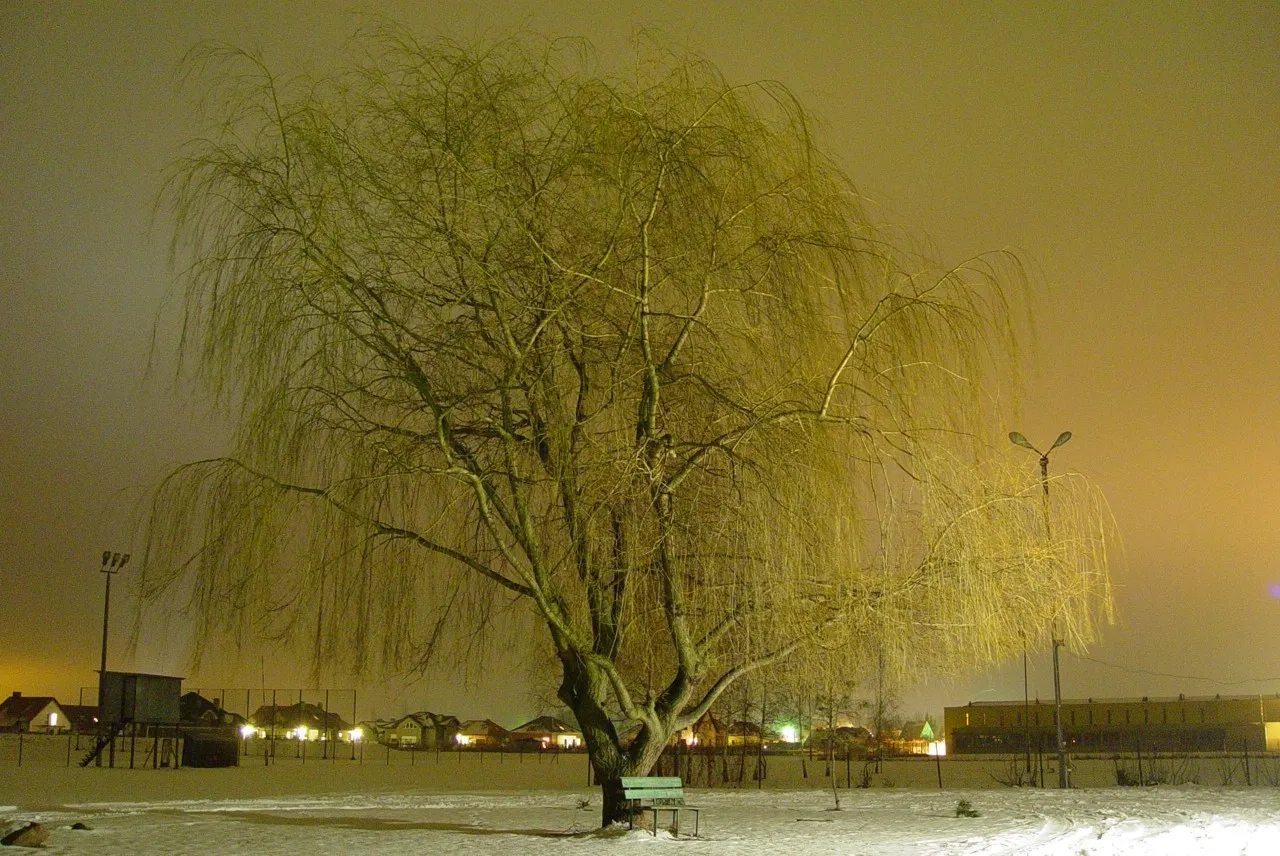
[943,695,1280,754]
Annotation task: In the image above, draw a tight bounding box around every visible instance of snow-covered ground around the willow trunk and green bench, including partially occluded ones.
[0,764,1280,856]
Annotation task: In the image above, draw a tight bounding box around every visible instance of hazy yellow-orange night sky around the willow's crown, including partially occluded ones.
[0,0,1280,724]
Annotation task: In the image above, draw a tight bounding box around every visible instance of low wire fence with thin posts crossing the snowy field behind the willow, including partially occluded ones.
[0,733,1280,802]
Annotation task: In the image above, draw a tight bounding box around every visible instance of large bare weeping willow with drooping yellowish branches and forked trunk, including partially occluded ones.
[142,32,1108,823]
